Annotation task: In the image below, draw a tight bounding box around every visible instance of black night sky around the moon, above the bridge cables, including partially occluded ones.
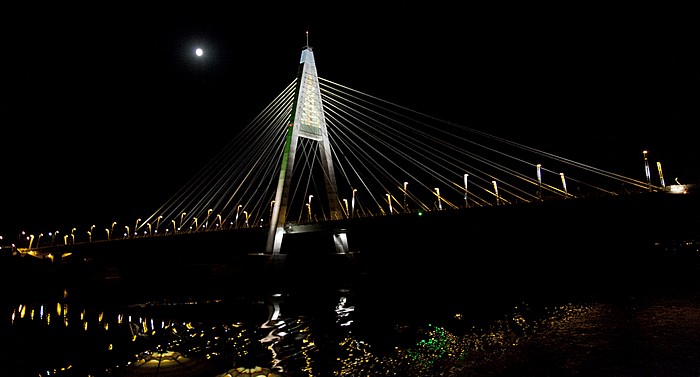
[0,1,700,235]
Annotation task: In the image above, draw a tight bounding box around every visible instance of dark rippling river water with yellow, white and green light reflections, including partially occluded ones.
[0,290,700,376]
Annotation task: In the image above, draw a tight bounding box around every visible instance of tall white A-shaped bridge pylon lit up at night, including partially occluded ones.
[266,46,347,254]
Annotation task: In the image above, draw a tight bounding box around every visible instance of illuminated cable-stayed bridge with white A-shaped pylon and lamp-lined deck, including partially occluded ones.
[20,47,688,266]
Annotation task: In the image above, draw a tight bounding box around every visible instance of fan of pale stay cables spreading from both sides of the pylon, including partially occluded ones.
[140,78,660,234]
